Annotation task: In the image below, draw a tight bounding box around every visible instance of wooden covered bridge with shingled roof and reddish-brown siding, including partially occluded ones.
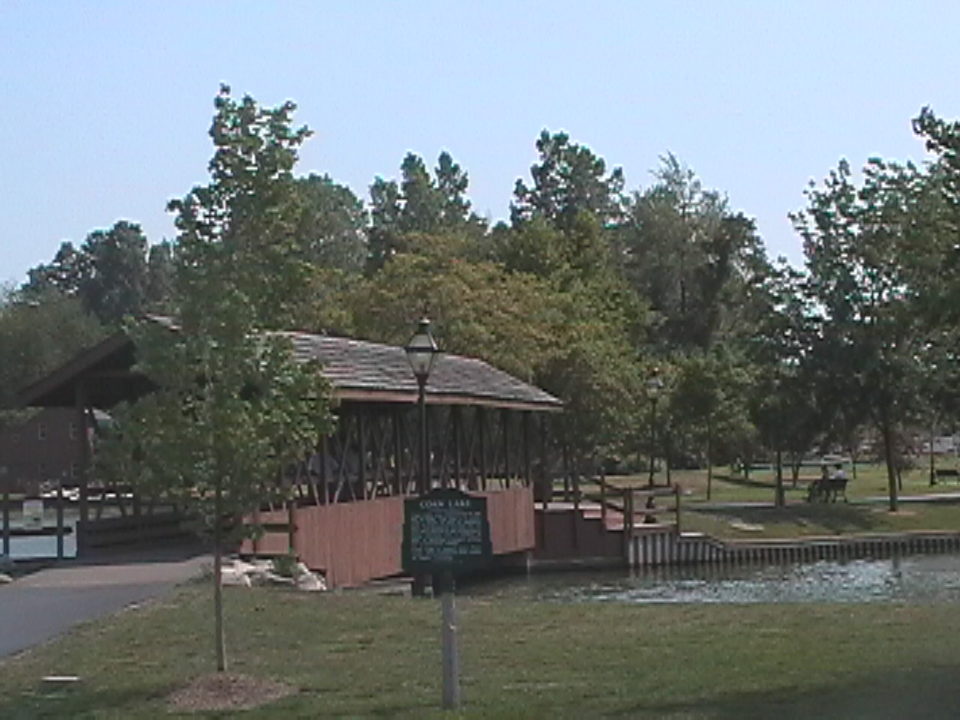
[15,324,562,587]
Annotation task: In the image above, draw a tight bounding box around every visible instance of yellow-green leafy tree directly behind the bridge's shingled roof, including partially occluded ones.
[344,216,643,464]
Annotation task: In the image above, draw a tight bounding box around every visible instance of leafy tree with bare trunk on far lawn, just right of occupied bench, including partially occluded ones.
[792,159,936,511]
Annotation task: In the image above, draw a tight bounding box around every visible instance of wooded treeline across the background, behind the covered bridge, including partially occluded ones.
[0,90,960,506]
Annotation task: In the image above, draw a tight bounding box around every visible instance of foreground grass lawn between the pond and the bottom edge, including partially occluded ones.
[0,585,960,719]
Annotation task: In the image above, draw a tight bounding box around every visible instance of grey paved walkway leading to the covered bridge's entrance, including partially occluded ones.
[0,550,211,658]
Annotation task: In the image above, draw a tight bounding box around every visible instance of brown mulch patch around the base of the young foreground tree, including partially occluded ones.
[168,673,297,712]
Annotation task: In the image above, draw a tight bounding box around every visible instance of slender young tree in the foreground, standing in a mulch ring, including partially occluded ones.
[102,87,331,671]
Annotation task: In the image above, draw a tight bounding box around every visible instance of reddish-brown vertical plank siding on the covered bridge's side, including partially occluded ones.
[242,487,535,587]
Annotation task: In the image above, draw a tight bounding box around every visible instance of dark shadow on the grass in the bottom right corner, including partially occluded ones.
[611,666,960,720]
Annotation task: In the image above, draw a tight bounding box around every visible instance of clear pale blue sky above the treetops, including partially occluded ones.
[0,0,960,282]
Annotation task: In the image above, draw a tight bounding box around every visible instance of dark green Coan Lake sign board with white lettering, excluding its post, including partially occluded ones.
[403,488,493,573]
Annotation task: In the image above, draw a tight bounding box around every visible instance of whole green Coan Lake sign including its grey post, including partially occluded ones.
[402,488,493,710]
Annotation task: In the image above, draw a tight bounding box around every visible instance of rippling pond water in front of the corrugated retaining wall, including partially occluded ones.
[463,554,960,603]
